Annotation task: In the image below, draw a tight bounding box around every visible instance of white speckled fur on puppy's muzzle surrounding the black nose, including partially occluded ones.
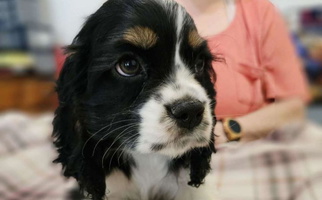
[136,61,212,157]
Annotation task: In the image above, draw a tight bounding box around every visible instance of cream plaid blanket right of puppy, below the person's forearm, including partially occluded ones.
[212,124,322,200]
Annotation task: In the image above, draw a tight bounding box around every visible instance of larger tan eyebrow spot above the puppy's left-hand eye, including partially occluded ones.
[123,26,158,49]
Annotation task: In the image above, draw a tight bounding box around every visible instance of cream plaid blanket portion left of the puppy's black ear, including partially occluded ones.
[0,113,76,200]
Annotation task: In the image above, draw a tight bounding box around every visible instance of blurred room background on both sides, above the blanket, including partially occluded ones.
[0,0,322,123]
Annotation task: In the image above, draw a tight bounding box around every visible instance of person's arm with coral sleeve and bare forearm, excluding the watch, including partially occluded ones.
[215,1,310,144]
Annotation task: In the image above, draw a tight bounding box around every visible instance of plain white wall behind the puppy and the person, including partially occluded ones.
[44,0,322,45]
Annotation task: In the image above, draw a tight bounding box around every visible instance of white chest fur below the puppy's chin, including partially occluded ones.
[106,153,218,200]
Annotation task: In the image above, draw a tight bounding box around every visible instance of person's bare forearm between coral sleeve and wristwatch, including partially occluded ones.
[236,98,305,141]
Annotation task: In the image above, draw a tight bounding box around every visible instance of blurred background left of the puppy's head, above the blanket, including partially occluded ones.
[0,0,103,113]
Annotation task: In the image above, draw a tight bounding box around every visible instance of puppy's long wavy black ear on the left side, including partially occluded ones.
[53,14,105,200]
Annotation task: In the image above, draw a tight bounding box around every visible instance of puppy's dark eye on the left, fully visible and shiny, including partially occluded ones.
[116,58,141,77]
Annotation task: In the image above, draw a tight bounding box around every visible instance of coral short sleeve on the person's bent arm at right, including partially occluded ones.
[259,0,310,102]
